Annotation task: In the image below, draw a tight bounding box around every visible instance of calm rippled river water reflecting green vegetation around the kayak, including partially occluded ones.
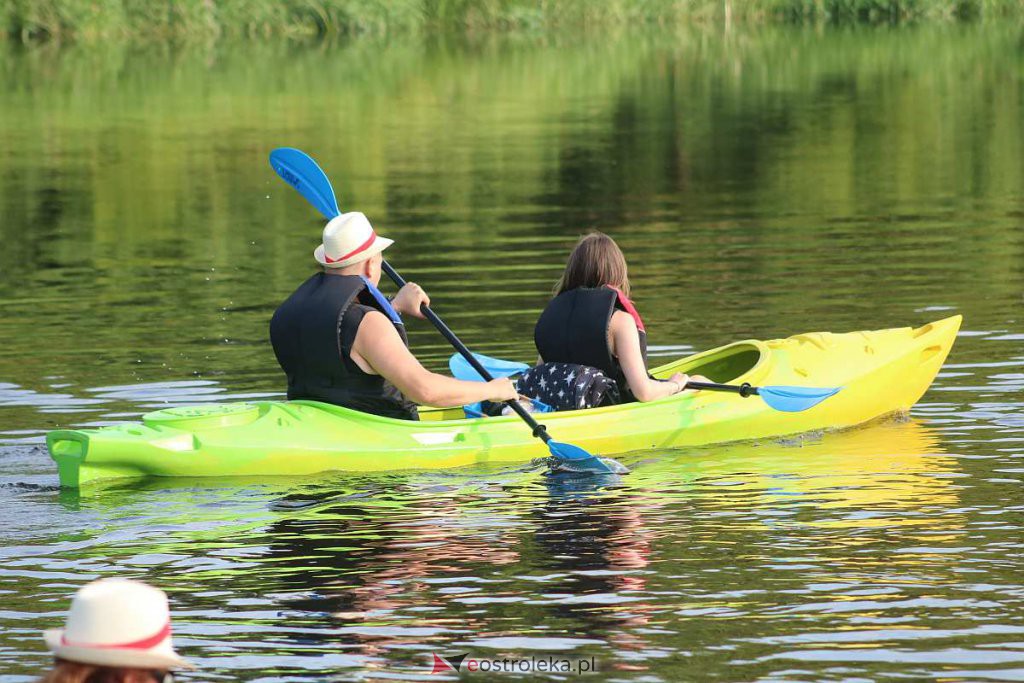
[0,25,1024,681]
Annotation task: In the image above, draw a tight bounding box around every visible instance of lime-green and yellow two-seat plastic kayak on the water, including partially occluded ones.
[46,315,962,487]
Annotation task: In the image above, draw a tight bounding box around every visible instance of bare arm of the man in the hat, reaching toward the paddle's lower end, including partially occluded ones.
[351,311,519,408]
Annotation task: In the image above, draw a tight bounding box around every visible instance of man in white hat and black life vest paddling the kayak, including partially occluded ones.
[270,211,517,420]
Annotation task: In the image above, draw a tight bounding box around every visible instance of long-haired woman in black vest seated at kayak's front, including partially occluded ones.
[519,231,703,408]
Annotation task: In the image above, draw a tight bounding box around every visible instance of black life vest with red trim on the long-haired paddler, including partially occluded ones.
[534,286,647,402]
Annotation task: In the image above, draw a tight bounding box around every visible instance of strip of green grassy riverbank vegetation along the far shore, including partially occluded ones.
[0,0,1024,41]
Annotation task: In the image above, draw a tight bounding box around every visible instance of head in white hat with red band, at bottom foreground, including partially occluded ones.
[40,579,194,683]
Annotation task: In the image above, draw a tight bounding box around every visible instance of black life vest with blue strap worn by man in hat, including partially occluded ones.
[270,272,419,420]
